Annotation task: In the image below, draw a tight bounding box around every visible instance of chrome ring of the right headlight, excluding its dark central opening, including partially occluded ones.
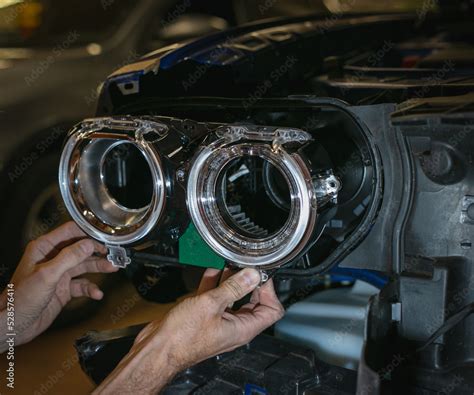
[187,128,317,268]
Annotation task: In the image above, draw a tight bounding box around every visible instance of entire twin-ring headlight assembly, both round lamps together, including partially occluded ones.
[59,116,341,270]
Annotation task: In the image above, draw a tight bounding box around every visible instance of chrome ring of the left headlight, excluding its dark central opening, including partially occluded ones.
[59,119,166,245]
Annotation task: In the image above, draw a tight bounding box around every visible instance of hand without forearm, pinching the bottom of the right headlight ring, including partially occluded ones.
[154,269,284,370]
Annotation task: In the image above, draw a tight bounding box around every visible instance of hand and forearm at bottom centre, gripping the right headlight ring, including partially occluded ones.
[94,269,284,394]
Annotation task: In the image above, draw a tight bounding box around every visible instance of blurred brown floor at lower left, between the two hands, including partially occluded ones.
[0,276,186,395]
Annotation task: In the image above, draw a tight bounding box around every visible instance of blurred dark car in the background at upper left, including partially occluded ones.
[0,0,233,281]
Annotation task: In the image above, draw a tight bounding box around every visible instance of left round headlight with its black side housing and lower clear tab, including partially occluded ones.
[59,117,198,267]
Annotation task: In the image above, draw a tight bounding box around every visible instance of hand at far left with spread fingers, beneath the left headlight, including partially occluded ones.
[0,222,118,352]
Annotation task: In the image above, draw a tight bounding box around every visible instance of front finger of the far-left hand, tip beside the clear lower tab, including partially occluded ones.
[45,239,95,281]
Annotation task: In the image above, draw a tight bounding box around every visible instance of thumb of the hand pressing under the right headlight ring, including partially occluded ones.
[210,269,260,310]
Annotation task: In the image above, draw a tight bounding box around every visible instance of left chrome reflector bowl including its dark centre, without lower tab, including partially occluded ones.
[59,118,167,245]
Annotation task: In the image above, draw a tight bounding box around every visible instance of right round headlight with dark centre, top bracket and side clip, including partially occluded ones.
[186,125,341,270]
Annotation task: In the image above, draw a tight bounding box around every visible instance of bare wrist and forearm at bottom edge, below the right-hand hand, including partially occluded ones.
[93,336,177,395]
